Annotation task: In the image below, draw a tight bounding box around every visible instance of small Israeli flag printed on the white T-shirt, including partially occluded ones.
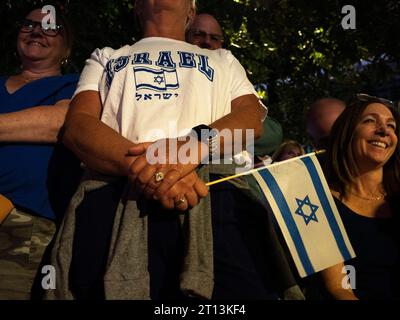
[133,67,179,92]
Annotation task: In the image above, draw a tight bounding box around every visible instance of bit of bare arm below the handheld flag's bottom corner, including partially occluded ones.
[321,263,358,300]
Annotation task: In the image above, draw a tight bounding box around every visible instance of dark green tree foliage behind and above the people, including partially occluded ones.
[0,0,400,140]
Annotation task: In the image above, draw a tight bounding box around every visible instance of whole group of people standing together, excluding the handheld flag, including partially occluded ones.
[0,0,400,300]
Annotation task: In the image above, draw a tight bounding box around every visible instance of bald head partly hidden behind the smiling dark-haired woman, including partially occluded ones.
[306,98,346,149]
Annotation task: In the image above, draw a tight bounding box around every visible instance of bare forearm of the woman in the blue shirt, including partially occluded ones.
[0,99,70,143]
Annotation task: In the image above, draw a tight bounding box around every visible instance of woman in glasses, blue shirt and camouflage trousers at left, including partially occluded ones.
[0,8,78,299]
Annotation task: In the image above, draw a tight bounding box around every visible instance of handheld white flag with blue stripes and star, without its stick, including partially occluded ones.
[253,154,355,277]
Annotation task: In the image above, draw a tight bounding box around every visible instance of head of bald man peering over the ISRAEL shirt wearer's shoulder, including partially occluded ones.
[186,13,223,50]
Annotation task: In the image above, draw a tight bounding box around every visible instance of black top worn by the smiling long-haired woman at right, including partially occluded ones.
[335,198,400,299]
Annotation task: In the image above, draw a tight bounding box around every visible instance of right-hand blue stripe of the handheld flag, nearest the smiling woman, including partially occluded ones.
[301,157,351,260]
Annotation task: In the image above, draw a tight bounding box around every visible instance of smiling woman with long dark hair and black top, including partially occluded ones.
[322,94,400,299]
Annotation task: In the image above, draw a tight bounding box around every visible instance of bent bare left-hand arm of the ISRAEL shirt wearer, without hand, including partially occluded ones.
[62,91,143,176]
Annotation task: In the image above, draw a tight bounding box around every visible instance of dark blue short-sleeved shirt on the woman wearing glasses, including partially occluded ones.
[0,74,79,219]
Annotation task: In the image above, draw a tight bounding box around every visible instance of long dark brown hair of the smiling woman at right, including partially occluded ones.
[324,95,400,198]
